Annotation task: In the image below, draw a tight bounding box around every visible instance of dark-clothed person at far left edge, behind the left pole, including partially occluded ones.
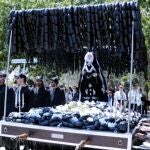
[0,71,15,119]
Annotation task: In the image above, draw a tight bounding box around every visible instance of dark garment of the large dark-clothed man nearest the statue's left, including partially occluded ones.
[51,87,65,107]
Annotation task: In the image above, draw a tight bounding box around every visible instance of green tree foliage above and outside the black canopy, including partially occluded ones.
[0,0,150,79]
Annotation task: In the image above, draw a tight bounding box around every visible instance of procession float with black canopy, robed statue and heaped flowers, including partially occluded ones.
[0,2,147,150]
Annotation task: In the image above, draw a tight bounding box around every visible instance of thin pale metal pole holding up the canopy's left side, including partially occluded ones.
[3,30,12,120]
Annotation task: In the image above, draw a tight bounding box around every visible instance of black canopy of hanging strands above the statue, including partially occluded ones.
[7,2,147,75]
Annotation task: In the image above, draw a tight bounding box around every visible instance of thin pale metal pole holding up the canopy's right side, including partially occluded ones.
[127,21,134,133]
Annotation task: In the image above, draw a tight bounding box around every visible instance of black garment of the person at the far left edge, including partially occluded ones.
[0,85,15,119]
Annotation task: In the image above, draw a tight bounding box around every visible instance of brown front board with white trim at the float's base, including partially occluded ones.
[0,121,132,150]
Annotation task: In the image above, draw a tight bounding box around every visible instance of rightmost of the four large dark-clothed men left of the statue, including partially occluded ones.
[50,77,65,107]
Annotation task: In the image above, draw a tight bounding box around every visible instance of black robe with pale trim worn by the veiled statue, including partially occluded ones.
[79,54,108,102]
